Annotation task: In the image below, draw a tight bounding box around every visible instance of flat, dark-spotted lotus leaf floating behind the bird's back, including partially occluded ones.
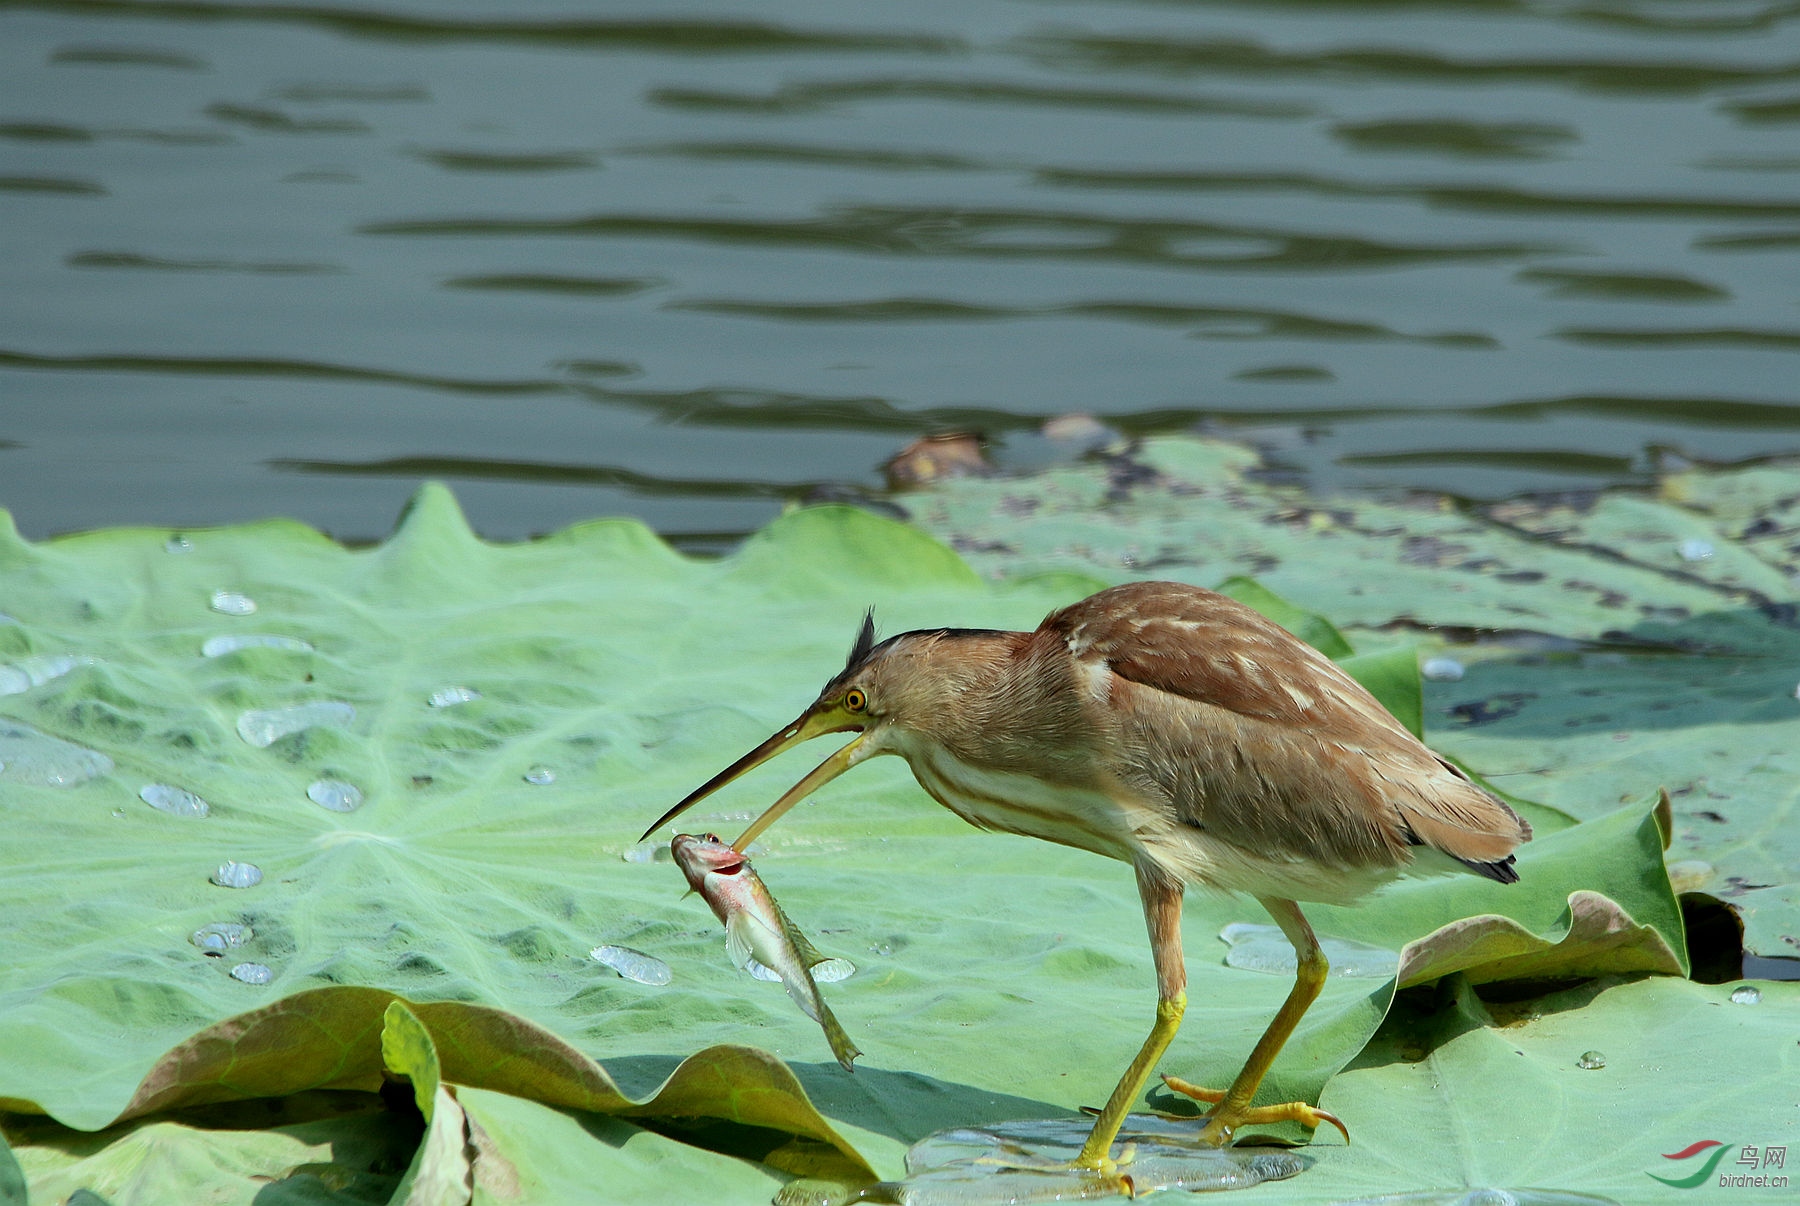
[902,437,1800,958]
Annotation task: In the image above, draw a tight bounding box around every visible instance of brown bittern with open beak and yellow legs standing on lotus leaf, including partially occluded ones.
[646,581,1532,1168]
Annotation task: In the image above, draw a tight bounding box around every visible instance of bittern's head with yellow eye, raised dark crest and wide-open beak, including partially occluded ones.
[644,610,997,851]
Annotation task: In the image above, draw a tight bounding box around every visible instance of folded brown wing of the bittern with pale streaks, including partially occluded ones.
[1044,581,1530,880]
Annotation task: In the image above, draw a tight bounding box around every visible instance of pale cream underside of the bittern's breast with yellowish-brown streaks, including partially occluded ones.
[907,749,1152,862]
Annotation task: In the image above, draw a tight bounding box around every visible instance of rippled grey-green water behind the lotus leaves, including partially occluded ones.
[0,0,1800,547]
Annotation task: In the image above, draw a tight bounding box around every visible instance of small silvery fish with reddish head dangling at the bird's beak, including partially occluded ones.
[670,833,862,1071]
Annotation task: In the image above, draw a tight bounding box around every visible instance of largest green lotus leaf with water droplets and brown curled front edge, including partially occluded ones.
[0,488,1713,1199]
